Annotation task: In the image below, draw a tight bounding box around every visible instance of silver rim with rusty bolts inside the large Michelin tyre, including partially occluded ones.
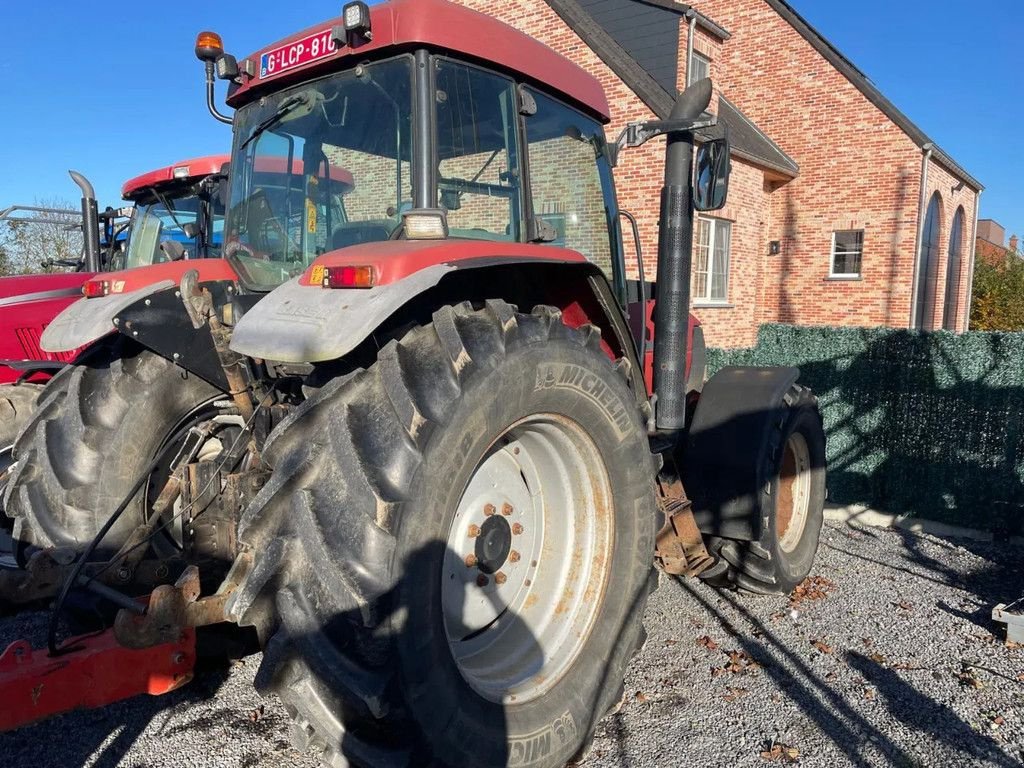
[441,414,613,703]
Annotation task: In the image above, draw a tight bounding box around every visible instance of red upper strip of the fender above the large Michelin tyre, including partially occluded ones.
[299,240,587,290]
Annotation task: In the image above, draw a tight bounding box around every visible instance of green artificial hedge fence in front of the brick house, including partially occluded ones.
[708,325,1024,535]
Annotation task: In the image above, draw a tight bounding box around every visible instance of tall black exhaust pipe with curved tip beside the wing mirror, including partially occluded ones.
[654,79,712,432]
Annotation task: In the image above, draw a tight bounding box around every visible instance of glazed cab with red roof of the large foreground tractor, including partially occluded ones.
[204,0,625,295]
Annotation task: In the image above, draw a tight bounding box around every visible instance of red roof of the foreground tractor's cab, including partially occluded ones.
[227,0,609,122]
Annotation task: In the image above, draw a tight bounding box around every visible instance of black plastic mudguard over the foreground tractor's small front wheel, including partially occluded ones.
[681,367,800,541]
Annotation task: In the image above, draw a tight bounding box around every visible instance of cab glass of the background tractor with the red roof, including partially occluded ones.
[125,195,224,269]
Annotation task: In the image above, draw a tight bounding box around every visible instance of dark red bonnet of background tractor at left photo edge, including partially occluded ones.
[0,272,93,384]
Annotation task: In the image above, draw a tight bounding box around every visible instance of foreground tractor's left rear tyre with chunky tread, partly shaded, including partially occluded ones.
[5,338,224,557]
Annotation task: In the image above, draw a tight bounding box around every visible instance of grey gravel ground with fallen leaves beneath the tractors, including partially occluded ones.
[0,523,1024,768]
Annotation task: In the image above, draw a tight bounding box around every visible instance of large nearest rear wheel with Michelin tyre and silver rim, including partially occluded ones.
[229,301,657,768]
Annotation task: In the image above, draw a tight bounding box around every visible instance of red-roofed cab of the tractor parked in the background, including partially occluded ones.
[116,155,228,270]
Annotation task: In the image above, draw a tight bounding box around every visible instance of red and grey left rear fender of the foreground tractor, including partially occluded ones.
[39,259,238,352]
